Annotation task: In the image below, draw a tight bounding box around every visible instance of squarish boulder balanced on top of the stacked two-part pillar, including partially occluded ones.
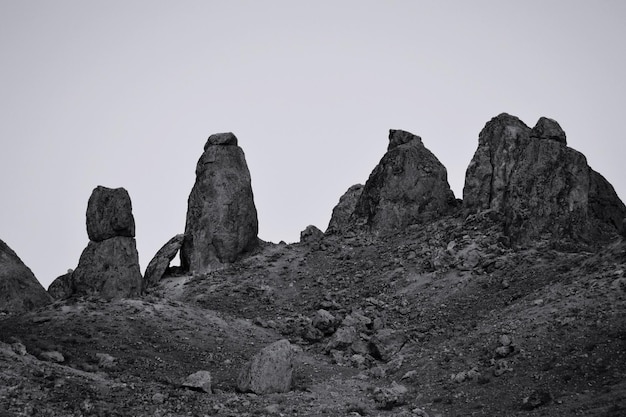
[87,186,135,242]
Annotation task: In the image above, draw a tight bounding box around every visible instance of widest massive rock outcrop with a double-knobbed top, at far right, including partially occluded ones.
[463,113,626,241]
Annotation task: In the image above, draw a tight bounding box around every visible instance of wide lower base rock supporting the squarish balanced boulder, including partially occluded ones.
[72,236,142,300]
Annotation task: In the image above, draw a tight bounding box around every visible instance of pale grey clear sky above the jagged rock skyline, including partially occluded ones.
[0,0,626,287]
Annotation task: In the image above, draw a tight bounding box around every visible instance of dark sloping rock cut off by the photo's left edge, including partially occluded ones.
[0,240,52,313]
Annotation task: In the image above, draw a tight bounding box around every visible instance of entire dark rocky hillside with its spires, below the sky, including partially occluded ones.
[0,118,626,417]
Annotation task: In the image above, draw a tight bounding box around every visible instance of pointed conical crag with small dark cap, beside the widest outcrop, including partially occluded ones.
[353,130,456,231]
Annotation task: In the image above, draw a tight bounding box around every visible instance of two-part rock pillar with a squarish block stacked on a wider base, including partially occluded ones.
[72,186,142,299]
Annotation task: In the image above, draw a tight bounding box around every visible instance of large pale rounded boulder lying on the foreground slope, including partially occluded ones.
[237,339,295,394]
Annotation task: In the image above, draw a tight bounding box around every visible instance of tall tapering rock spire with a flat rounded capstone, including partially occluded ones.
[181,133,258,272]
